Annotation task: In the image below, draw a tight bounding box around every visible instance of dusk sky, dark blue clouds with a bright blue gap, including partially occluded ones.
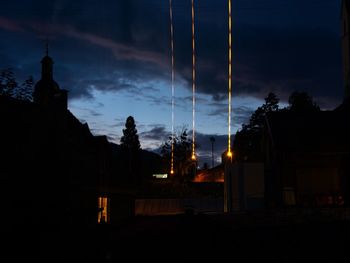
[0,0,343,167]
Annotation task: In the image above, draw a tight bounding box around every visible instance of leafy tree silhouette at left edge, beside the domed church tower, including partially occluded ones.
[0,68,34,101]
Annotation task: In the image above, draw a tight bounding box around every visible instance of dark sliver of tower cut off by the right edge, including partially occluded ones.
[341,0,350,103]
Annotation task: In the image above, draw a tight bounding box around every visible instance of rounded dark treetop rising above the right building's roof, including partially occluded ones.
[288,91,320,112]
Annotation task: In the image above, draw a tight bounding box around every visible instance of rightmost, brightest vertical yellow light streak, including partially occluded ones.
[227,0,232,158]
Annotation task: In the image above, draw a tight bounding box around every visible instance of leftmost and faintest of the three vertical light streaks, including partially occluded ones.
[169,0,175,177]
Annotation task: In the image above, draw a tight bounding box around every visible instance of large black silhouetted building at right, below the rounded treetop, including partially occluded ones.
[263,111,350,207]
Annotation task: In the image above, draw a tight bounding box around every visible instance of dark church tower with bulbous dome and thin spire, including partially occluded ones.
[33,44,67,109]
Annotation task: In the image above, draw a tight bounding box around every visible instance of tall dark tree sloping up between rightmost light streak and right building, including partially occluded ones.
[233,92,279,161]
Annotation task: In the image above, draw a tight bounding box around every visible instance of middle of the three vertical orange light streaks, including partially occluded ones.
[191,0,196,160]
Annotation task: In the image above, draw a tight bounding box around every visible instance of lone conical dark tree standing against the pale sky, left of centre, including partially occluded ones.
[120,116,141,180]
